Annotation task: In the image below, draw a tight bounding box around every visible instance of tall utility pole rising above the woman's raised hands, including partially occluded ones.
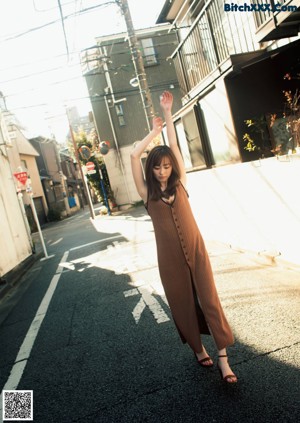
[116,0,155,131]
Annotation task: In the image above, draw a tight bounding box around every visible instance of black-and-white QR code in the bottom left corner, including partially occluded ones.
[2,391,33,421]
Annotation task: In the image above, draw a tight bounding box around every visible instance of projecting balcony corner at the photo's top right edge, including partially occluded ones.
[253,0,300,42]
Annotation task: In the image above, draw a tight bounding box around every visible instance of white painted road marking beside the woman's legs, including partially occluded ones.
[124,285,170,324]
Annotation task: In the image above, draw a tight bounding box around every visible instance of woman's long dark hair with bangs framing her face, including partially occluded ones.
[145,145,180,200]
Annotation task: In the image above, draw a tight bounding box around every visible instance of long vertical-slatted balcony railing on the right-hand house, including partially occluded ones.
[172,0,300,96]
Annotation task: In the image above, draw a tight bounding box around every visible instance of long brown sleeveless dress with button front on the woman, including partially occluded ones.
[146,183,234,352]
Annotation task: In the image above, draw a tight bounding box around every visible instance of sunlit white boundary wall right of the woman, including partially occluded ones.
[188,154,300,265]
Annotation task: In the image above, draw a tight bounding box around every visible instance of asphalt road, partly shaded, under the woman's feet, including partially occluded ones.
[0,208,300,423]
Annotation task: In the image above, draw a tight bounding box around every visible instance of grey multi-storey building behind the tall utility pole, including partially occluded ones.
[82,25,181,206]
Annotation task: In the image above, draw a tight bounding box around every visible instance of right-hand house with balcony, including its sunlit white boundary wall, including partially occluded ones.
[157,0,300,263]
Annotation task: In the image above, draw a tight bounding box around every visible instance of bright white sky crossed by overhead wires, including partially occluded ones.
[0,0,165,142]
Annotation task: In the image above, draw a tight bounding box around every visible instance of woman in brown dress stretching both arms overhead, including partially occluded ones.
[131,91,237,383]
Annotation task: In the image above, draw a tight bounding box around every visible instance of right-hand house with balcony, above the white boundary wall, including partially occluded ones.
[157,0,300,169]
